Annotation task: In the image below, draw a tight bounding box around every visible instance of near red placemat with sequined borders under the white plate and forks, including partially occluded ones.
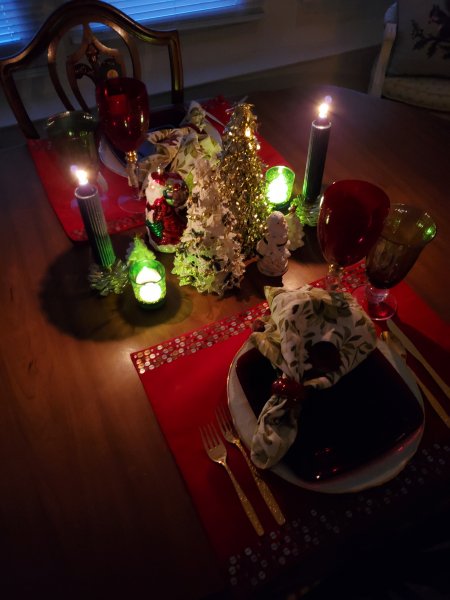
[131,264,450,597]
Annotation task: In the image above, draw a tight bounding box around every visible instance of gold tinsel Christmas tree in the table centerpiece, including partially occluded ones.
[218,103,270,258]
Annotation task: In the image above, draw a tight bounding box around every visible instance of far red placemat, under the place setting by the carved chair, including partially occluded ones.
[28,97,289,241]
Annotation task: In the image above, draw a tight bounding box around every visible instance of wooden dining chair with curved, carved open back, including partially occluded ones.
[0,0,184,139]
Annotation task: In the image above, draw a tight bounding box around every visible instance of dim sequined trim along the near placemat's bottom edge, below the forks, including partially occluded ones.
[226,443,450,597]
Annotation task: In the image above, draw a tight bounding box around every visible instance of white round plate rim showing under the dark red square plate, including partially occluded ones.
[227,340,424,494]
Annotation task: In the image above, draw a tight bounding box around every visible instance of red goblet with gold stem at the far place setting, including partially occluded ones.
[96,77,150,213]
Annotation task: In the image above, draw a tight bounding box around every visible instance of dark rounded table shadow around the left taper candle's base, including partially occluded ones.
[39,245,192,341]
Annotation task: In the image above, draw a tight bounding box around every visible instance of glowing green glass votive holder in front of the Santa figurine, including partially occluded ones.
[129,259,166,309]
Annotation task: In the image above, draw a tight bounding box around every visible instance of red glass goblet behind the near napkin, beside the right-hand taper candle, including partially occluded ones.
[317,179,390,291]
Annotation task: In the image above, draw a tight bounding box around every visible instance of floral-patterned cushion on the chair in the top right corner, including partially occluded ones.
[388,0,450,78]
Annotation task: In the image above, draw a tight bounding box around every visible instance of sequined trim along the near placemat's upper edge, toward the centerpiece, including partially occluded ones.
[131,263,366,374]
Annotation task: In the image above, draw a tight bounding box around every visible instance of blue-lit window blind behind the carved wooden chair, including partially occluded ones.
[0,0,262,49]
